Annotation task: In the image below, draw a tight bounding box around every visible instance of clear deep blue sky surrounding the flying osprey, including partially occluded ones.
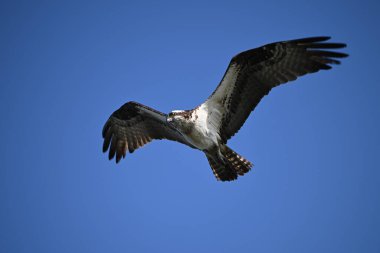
[0,0,380,253]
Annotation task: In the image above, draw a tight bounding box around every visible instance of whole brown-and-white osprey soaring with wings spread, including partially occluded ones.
[102,37,348,181]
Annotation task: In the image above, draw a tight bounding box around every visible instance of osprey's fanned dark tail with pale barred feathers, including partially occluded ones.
[206,145,253,181]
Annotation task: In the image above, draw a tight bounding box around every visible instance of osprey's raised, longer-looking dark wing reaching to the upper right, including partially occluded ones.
[203,37,348,142]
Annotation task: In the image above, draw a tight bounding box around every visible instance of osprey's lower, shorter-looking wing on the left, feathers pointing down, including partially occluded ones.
[102,102,192,163]
